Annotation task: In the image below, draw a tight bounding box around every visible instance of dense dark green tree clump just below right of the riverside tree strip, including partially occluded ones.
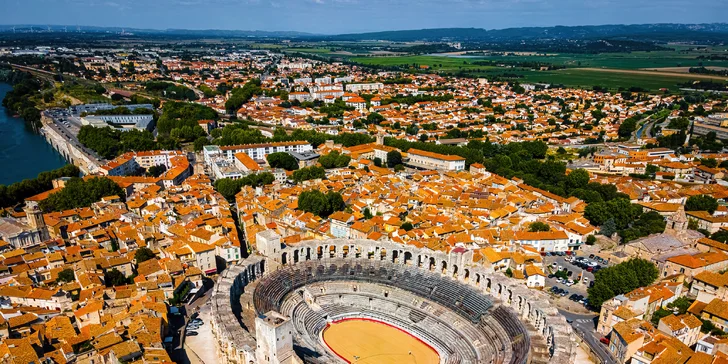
[39,177,125,212]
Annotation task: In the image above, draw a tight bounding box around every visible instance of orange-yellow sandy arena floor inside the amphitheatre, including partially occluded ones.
[323,319,440,364]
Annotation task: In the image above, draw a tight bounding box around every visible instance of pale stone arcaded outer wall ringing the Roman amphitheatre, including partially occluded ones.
[211,239,577,364]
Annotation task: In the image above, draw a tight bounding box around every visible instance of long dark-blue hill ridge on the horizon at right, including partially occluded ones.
[321,23,728,43]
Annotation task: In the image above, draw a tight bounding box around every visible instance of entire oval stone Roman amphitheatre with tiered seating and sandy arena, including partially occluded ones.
[211,230,577,364]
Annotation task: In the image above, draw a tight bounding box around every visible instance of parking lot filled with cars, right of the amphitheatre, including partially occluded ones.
[544,254,609,307]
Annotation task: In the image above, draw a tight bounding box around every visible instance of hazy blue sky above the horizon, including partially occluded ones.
[0,0,728,34]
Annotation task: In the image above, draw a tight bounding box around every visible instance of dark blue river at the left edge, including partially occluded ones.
[0,83,66,185]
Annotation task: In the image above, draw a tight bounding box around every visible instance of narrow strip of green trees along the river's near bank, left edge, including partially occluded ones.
[0,164,81,208]
